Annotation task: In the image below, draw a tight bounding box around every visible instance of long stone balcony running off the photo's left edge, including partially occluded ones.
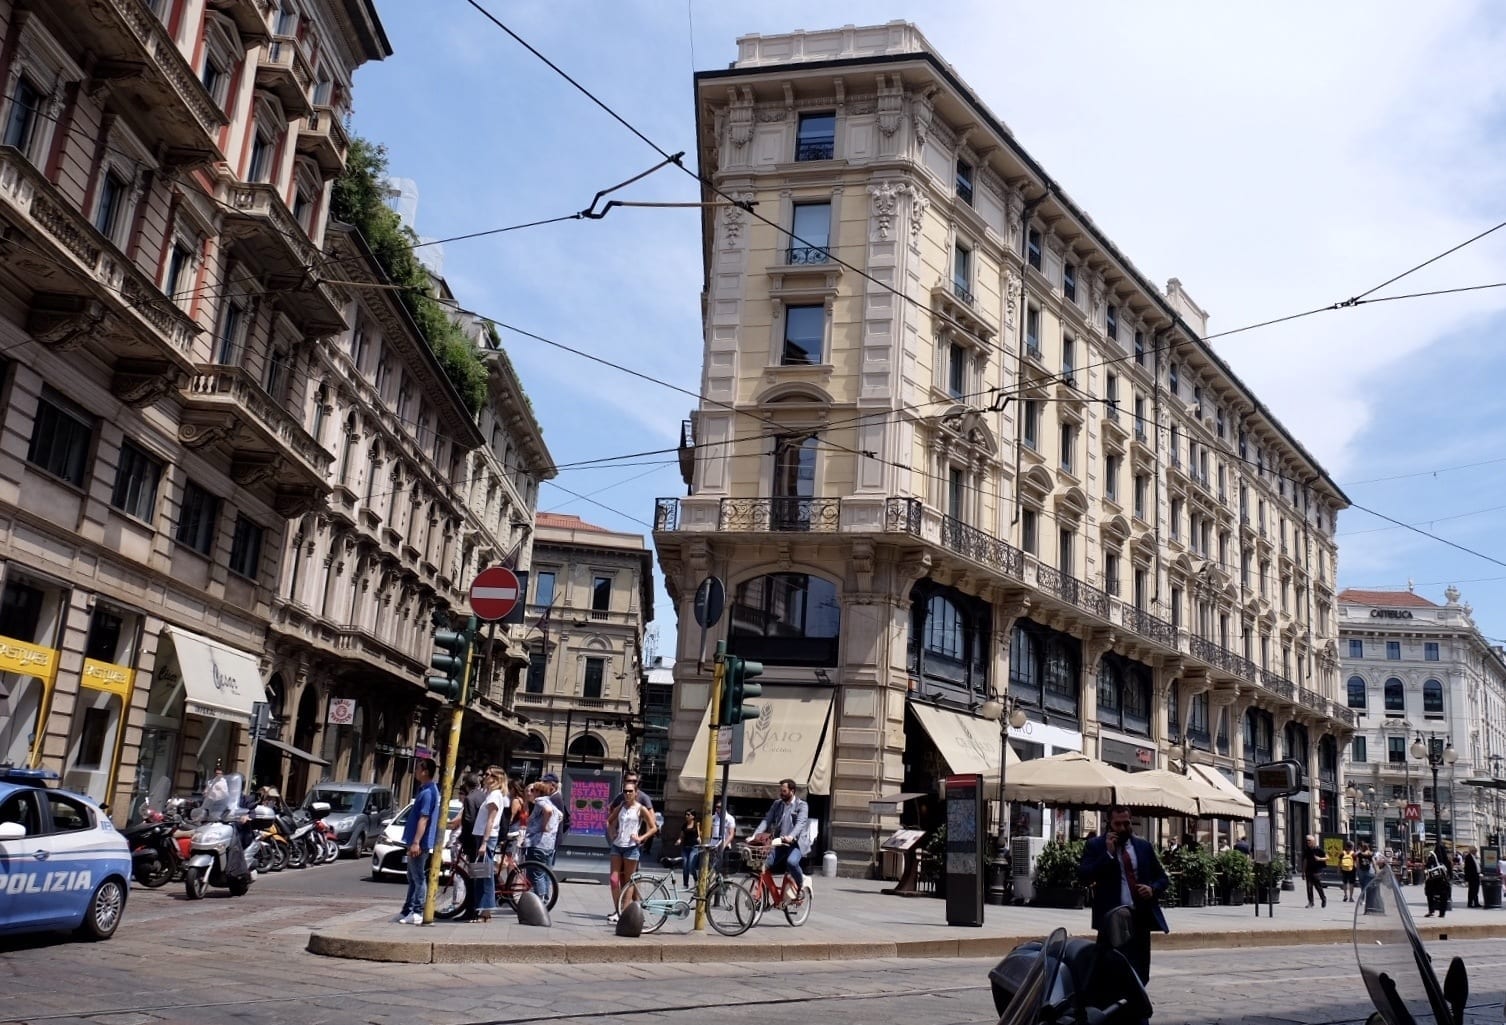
[0,146,199,369]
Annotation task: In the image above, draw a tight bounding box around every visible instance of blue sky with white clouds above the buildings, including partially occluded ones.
[354,0,1506,655]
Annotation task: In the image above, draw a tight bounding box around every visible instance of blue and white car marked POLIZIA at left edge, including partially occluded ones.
[0,766,131,939]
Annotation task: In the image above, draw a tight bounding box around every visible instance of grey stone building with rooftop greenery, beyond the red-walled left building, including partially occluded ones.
[256,224,554,798]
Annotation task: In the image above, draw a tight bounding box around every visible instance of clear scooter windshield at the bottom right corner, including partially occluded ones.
[1354,865,1452,1025]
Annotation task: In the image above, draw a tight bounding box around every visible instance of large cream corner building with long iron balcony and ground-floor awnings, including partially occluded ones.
[655,23,1354,868]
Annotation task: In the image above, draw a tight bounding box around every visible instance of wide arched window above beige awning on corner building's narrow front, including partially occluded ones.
[729,573,842,665]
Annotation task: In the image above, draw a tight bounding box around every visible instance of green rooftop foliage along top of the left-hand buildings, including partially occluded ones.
[330,138,486,417]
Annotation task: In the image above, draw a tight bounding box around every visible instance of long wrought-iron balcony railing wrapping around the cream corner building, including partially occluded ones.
[654,497,1354,725]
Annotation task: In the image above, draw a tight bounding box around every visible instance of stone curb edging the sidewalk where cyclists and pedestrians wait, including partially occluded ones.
[307,923,1506,965]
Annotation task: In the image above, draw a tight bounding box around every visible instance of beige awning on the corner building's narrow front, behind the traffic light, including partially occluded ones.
[679,685,834,799]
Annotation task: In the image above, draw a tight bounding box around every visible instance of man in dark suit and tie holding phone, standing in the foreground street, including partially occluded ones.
[1077,807,1172,983]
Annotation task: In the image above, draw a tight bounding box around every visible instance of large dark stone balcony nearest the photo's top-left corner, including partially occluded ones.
[65,0,229,164]
